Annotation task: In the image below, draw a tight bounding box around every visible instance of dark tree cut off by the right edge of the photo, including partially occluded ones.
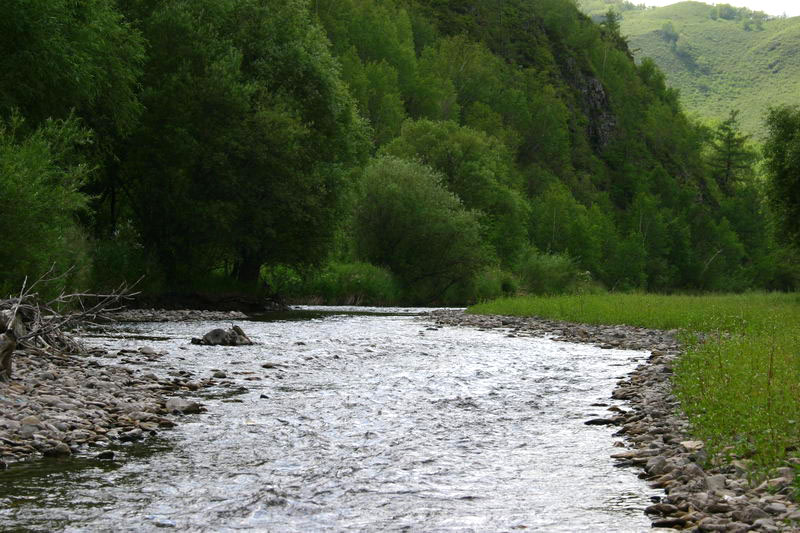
[764,106,800,246]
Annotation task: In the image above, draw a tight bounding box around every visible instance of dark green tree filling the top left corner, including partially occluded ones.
[0,0,145,237]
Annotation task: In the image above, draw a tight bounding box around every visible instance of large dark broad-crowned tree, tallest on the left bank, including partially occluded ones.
[123,0,367,284]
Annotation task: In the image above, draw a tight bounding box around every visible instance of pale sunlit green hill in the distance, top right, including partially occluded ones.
[581,0,800,137]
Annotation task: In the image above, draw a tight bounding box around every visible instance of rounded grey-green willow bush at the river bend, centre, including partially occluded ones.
[354,156,491,304]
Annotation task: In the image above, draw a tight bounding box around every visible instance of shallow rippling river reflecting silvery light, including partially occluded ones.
[0,309,655,532]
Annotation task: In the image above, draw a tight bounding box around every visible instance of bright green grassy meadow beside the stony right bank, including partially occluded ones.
[470,293,800,473]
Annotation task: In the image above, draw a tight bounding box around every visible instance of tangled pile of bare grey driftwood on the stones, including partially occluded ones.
[0,268,138,380]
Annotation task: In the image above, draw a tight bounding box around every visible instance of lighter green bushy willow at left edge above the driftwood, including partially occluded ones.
[0,114,90,294]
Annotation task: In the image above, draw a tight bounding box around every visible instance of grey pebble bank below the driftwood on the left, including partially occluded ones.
[0,347,222,469]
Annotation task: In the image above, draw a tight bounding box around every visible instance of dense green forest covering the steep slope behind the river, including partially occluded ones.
[0,0,800,304]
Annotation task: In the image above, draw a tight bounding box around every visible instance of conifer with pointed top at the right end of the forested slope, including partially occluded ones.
[708,110,758,195]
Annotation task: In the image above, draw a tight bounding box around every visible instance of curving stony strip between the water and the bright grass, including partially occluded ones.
[431,310,800,533]
